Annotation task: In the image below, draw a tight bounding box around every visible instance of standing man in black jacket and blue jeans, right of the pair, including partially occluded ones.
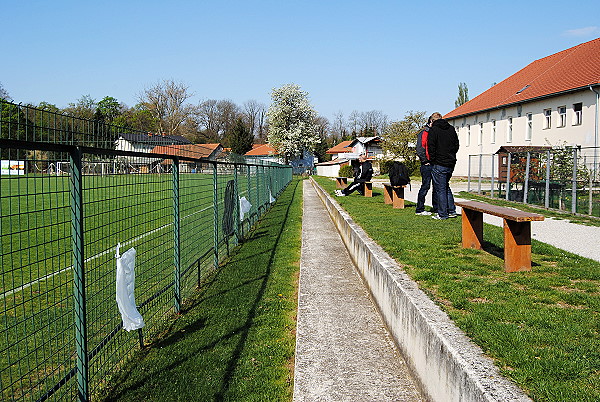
[427,112,459,219]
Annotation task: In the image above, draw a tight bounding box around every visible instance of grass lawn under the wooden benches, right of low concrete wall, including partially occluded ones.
[316,177,600,401]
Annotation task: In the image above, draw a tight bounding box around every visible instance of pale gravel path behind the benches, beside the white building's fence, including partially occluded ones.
[374,181,600,261]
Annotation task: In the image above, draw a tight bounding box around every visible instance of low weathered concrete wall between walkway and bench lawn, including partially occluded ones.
[311,178,530,402]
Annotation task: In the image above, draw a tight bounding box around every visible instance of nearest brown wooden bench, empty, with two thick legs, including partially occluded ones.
[455,201,544,272]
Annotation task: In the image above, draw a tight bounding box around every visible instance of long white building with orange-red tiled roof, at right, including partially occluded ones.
[444,38,600,176]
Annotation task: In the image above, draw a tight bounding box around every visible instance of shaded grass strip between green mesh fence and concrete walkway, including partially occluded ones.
[104,179,302,401]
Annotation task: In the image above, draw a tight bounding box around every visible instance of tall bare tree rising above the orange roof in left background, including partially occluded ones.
[138,80,193,135]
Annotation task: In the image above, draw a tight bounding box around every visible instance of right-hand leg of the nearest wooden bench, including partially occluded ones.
[504,219,531,272]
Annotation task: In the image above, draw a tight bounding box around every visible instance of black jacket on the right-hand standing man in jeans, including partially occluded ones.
[427,119,459,168]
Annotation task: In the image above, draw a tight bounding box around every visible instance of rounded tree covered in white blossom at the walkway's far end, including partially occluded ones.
[267,84,321,163]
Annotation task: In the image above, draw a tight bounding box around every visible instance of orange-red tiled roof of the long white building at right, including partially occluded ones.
[444,38,600,118]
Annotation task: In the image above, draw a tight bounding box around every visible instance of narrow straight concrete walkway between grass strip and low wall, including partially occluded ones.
[294,180,423,402]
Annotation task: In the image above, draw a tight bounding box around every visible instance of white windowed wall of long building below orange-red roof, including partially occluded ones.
[448,89,600,176]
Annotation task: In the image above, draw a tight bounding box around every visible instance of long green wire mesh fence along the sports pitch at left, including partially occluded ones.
[0,102,292,401]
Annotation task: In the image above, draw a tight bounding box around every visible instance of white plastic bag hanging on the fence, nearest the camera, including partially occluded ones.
[115,243,145,331]
